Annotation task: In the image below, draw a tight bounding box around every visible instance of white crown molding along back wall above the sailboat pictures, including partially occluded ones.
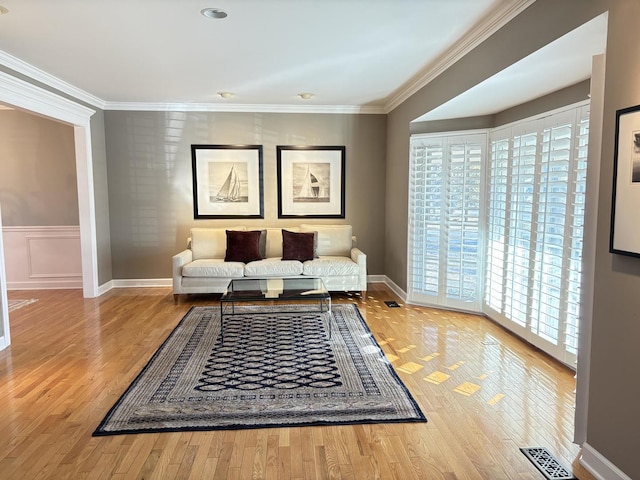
[104,102,387,114]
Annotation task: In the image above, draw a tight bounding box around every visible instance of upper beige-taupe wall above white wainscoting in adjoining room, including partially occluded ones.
[0,110,79,227]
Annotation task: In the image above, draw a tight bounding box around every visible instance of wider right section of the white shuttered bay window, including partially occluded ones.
[484,106,588,364]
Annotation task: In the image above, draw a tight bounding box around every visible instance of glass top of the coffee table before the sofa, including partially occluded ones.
[221,277,330,302]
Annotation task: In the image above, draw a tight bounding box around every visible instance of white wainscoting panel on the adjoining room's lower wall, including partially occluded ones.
[2,226,82,290]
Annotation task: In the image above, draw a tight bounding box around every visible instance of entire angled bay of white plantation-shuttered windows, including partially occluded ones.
[408,105,589,364]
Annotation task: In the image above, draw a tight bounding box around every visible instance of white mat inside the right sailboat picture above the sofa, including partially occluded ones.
[280,150,343,216]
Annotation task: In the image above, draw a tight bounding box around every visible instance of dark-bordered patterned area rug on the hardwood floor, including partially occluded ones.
[93,304,426,436]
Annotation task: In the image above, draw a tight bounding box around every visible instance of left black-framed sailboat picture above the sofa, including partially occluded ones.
[191,145,264,219]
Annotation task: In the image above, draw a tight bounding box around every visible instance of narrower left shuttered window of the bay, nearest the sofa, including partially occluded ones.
[409,134,486,311]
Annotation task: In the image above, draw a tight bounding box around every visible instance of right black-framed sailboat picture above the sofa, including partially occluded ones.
[276,145,346,218]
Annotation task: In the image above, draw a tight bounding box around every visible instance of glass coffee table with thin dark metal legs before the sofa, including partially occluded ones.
[220,277,332,342]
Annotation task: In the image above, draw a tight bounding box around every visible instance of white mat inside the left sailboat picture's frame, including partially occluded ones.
[195,148,261,216]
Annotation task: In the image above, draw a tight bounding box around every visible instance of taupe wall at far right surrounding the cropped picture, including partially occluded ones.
[587,0,640,478]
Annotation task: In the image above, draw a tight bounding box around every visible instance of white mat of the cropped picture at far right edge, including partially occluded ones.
[612,112,640,254]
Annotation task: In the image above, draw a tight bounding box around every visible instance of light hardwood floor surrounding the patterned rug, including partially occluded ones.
[0,284,593,480]
